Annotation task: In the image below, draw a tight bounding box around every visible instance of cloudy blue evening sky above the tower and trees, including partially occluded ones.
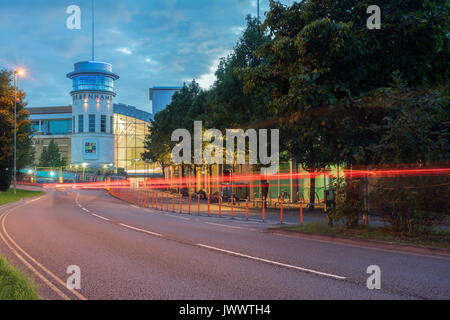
[0,0,293,111]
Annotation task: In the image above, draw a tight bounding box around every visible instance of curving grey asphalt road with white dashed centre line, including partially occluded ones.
[0,190,450,300]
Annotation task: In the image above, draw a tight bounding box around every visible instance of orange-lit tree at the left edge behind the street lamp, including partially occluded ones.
[0,70,34,191]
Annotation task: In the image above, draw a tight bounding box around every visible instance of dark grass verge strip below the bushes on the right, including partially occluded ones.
[281,222,450,249]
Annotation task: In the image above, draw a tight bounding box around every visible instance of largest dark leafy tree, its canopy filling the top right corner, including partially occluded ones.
[242,0,449,216]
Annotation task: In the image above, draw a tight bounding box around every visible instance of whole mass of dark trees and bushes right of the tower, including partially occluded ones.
[146,0,450,245]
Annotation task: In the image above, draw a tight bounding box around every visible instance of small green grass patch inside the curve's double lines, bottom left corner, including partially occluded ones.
[0,257,38,300]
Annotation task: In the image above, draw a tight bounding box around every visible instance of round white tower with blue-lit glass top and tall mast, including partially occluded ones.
[67,1,119,168]
